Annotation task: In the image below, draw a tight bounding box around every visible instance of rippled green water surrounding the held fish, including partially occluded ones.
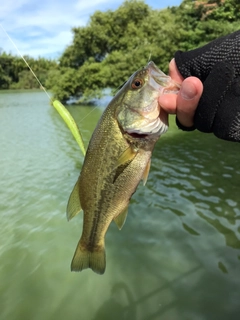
[0,92,240,320]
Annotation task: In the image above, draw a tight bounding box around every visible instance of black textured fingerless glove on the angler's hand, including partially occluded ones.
[175,30,240,142]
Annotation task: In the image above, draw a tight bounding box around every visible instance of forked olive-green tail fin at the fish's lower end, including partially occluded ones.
[71,240,106,274]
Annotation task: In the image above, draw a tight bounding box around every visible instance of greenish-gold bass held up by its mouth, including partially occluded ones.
[67,61,179,274]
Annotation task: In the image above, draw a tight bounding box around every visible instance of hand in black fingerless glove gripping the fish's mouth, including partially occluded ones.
[159,30,240,142]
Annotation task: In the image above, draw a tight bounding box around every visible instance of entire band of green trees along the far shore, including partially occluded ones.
[0,0,240,102]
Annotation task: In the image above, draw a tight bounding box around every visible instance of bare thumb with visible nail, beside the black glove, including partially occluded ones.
[176,77,203,127]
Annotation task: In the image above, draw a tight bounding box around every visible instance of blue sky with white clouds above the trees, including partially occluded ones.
[0,0,182,58]
